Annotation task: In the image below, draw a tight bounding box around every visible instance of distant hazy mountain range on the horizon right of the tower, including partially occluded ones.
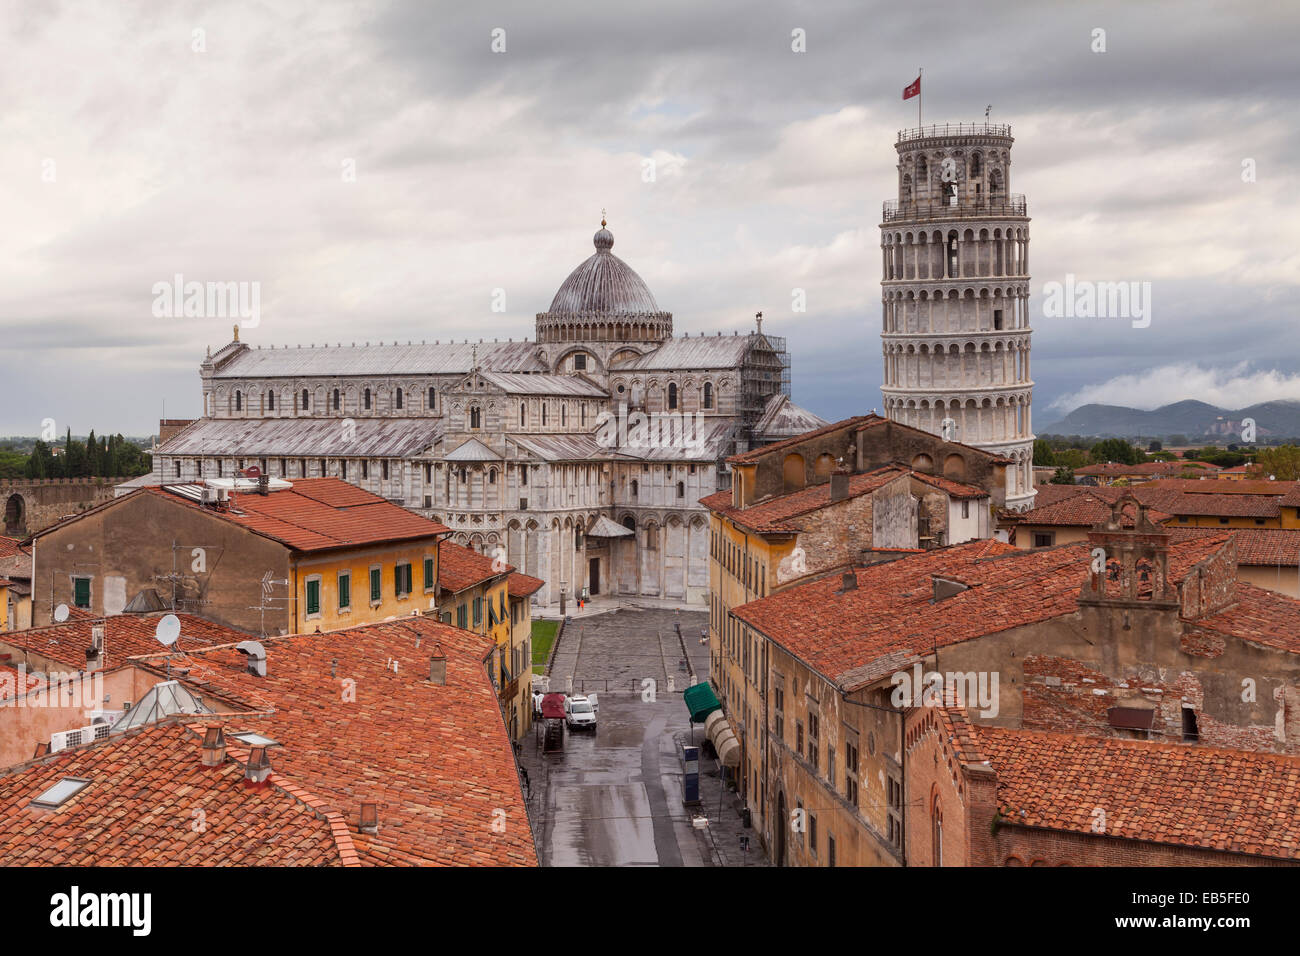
[1034,399,1300,441]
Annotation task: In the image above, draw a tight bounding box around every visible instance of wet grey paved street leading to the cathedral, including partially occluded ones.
[521,609,762,866]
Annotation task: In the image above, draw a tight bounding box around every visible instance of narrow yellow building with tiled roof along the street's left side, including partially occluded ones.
[438,541,537,739]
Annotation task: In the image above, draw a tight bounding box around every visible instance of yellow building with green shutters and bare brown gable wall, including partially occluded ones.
[33,479,449,636]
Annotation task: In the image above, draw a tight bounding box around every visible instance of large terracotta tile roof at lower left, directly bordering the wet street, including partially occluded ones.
[126,617,537,866]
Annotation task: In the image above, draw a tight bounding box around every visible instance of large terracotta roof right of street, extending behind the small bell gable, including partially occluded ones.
[732,533,1229,691]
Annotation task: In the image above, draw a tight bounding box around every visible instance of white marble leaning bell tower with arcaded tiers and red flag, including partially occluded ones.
[880,124,1034,510]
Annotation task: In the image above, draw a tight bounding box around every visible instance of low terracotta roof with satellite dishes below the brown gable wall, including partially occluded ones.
[0,609,251,670]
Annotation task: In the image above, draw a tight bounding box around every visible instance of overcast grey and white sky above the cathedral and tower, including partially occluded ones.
[0,0,1300,434]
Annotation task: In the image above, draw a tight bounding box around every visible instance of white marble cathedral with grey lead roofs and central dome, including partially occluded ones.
[148,220,826,605]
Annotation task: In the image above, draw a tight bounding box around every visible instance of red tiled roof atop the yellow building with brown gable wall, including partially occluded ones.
[143,477,450,551]
